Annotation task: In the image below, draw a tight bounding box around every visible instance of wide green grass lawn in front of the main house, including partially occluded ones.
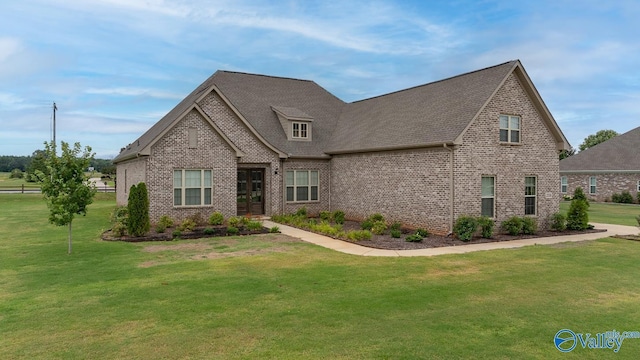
[0,194,640,359]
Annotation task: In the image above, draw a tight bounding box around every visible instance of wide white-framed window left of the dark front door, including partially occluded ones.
[173,169,212,206]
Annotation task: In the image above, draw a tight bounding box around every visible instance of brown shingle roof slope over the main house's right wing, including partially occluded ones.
[328,61,517,153]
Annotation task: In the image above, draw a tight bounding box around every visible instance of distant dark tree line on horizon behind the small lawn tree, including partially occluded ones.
[0,150,116,181]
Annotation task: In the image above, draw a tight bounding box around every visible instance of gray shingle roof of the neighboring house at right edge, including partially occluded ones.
[560,127,640,172]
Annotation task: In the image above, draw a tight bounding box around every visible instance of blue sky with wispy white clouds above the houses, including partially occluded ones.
[0,0,640,158]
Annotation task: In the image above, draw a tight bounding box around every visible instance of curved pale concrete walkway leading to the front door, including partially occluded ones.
[263,220,639,256]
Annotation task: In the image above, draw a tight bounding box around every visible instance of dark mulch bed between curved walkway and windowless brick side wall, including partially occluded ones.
[304,221,606,250]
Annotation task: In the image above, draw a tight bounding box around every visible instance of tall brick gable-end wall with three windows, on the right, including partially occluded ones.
[455,74,560,227]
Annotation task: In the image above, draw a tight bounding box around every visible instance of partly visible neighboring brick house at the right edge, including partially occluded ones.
[560,127,640,201]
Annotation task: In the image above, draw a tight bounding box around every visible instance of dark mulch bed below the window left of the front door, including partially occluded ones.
[101,226,269,242]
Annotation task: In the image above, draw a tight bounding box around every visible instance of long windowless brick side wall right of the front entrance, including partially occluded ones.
[331,148,450,233]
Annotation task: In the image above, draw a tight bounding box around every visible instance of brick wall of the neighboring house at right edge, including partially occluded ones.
[560,173,640,201]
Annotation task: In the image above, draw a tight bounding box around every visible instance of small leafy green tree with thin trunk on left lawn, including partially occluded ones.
[36,141,96,254]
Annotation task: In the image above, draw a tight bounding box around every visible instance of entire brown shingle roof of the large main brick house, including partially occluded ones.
[114,61,566,163]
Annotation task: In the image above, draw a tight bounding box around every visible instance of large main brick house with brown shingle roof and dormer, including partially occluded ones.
[114,61,569,233]
